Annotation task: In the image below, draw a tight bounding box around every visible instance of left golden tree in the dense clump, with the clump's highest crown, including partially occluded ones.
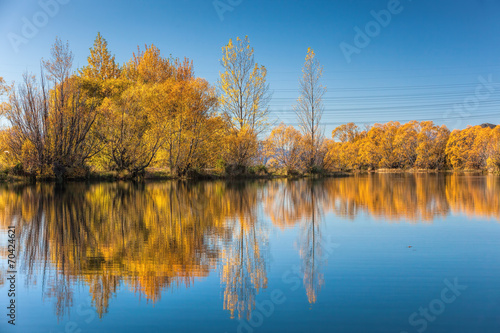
[96,45,174,175]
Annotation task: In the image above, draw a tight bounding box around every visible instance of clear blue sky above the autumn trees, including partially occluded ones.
[0,0,500,136]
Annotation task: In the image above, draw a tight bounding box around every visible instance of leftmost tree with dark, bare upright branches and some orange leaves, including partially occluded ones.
[4,39,98,179]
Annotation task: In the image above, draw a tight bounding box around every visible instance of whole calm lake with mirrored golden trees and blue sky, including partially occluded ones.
[0,174,500,333]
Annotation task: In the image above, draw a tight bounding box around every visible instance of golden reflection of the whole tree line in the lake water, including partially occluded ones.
[0,174,500,318]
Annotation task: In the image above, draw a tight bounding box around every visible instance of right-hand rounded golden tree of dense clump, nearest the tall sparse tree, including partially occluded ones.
[148,68,221,176]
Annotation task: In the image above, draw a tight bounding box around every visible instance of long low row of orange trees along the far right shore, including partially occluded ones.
[326,121,500,170]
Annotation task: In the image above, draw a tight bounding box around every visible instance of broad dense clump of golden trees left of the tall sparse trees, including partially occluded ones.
[97,45,225,176]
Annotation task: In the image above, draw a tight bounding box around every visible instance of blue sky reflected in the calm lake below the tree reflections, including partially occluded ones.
[0,206,500,333]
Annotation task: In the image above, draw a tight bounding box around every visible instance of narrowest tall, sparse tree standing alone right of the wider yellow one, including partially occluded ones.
[294,48,326,170]
